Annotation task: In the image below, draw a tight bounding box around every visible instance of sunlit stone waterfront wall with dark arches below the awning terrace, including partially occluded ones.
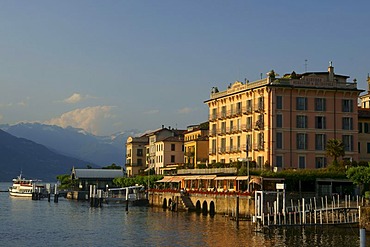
[149,191,254,217]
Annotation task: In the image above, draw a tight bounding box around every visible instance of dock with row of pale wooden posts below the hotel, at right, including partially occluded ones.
[253,191,363,228]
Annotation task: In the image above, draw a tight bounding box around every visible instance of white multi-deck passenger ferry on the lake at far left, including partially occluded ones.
[9,173,45,198]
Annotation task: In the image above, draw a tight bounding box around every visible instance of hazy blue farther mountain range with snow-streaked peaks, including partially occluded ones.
[0,123,139,166]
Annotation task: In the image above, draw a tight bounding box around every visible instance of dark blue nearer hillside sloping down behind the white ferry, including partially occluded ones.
[0,130,90,182]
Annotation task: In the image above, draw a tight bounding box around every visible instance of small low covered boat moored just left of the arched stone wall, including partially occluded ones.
[104,186,149,206]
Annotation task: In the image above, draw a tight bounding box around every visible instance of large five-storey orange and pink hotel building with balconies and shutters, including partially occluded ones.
[205,64,362,170]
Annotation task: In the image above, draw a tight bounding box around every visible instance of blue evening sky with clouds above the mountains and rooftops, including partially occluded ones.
[0,0,370,135]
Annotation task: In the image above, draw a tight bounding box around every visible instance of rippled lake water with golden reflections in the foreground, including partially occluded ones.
[0,183,370,247]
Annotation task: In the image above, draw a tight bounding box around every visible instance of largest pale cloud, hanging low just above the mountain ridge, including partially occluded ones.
[45,106,114,135]
